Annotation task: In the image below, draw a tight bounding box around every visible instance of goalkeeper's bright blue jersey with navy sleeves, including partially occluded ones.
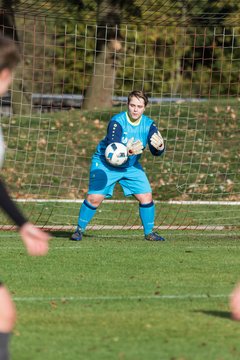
[94,111,164,168]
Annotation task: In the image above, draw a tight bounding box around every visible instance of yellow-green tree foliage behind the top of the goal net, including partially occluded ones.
[2,0,240,97]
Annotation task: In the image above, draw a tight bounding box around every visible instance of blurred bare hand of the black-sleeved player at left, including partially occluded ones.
[19,222,50,256]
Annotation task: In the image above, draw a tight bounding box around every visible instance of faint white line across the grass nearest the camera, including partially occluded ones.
[13,294,229,302]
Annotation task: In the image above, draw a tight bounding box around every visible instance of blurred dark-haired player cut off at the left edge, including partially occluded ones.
[0,36,49,360]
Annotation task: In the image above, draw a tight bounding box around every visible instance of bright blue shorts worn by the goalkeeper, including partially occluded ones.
[88,155,152,198]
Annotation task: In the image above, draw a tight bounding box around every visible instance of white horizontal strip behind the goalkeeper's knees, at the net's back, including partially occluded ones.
[15,198,240,206]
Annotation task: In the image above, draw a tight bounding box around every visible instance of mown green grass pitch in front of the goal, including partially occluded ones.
[0,231,240,360]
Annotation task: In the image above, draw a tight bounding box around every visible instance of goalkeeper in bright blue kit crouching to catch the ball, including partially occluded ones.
[71,91,164,241]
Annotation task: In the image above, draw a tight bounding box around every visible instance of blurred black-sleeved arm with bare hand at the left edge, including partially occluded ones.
[0,179,49,256]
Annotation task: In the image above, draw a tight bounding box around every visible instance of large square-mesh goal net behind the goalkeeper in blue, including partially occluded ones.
[0,7,240,229]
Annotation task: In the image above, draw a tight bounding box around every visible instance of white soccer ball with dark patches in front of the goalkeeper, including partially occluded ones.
[105,142,128,166]
